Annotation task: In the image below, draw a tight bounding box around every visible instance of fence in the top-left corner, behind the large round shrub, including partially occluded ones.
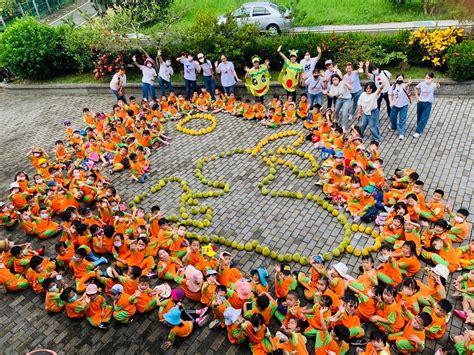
[0,0,74,31]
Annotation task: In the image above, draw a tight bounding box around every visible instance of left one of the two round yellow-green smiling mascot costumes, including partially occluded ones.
[244,56,271,103]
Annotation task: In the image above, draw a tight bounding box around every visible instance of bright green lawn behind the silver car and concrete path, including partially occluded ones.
[169,0,451,26]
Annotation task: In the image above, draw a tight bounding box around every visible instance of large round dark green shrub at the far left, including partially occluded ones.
[0,17,66,79]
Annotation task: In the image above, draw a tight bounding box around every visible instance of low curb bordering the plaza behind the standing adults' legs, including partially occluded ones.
[0,79,474,97]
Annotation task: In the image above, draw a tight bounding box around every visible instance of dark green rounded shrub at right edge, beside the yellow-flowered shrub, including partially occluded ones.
[446,40,474,81]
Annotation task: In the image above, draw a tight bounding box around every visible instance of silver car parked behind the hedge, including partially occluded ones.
[218,2,292,35]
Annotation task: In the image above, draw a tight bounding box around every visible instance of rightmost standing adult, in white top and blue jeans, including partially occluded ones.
[413,71,440,138]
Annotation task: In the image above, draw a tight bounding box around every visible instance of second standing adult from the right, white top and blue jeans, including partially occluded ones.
[388,74,412,140]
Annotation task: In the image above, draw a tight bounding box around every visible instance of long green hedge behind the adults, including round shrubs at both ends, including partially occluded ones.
[0,13,474,80]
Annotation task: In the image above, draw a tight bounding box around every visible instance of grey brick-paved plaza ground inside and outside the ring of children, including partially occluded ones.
[0,91,474,354]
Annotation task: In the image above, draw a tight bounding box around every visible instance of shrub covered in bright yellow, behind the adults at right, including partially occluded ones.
[409,27,464,67]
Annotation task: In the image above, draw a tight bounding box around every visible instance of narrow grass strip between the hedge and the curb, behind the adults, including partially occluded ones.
[14,67,448,84]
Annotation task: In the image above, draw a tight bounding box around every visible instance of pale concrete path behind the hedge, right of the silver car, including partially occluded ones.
[289,20,474,33]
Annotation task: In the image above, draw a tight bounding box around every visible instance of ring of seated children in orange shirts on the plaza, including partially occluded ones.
[0,57,468,355]
